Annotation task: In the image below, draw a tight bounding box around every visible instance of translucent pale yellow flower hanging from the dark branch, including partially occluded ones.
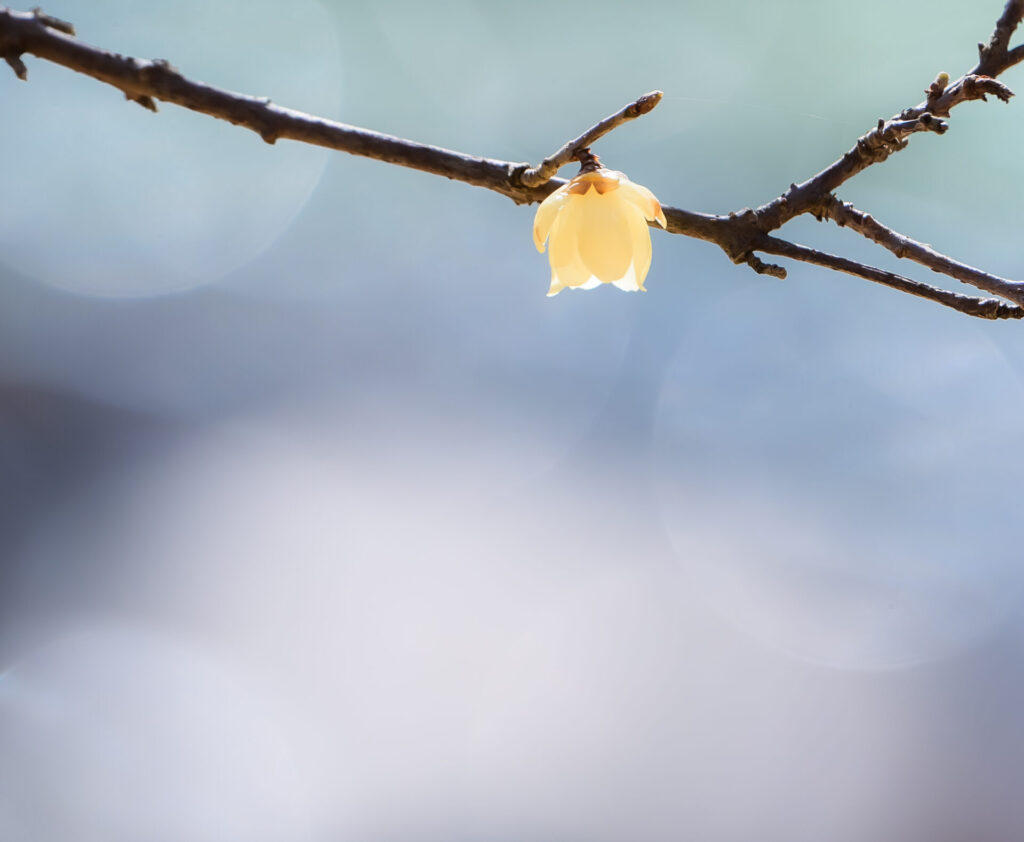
[534,167,666,296]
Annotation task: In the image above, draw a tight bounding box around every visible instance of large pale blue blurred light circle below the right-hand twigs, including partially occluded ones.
[655,281,1024,669]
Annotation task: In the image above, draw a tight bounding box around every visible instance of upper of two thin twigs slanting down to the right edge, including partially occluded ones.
[820,196,1024,305]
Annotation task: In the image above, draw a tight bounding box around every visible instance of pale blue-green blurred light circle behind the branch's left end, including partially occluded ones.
[0,0,342,297]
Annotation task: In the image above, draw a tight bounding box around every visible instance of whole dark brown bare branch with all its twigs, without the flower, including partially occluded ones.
[0,0,1024,319]
